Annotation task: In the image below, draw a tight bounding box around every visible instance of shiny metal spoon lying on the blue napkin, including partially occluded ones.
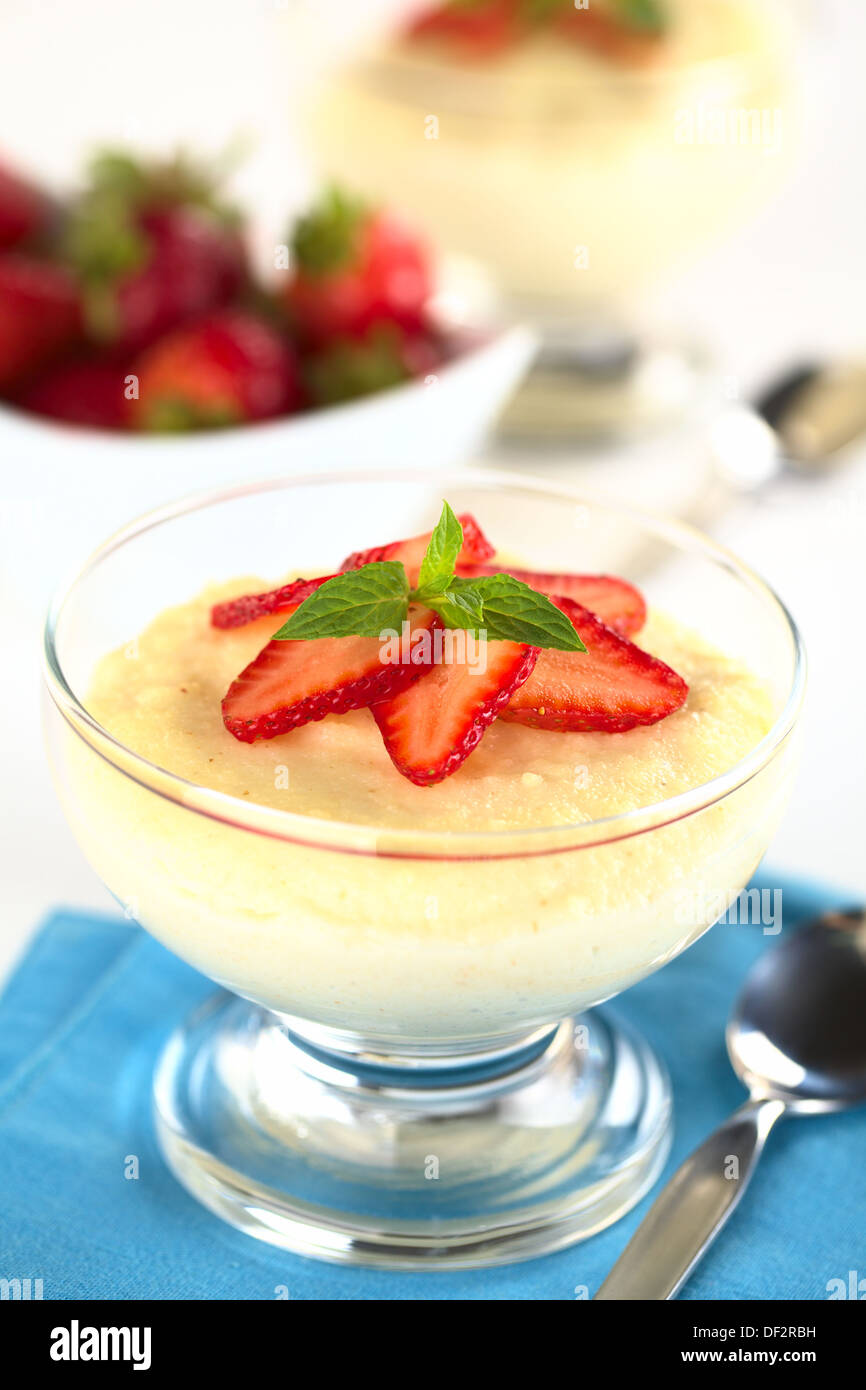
[595,909,866,1300]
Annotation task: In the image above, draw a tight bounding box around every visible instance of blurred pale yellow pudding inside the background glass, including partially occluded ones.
[311,0,795,309]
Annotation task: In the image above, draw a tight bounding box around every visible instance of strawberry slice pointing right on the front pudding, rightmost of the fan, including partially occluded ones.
[502,596,688,734]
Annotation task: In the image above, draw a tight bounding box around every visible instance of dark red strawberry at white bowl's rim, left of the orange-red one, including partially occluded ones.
[18,357,129,430]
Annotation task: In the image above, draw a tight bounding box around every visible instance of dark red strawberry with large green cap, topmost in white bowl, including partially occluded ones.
[68,153,247,356]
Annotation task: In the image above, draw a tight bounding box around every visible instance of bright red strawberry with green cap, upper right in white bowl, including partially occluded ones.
[284,189,432,346]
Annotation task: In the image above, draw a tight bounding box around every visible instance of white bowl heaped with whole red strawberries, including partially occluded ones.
[0,153,534,581]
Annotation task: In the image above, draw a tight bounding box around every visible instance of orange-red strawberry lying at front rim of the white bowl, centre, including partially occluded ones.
[131,310,302,431]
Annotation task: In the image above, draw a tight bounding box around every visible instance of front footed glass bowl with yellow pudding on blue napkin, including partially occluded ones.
[46,471,803,1268]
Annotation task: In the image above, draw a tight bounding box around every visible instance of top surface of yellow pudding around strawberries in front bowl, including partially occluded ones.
[89,577,773,831]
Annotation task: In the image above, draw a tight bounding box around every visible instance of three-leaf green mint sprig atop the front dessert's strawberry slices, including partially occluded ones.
[274,502,587,652]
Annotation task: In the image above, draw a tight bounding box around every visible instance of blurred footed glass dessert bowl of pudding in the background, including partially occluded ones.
[310,0,799,436]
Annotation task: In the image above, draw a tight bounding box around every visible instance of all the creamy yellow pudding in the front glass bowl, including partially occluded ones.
[61,578,788,1044]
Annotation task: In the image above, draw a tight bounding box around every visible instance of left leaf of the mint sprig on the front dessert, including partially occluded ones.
[274,560,409,642]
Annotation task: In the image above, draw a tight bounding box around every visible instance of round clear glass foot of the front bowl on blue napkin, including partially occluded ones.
[154,994,671,1269]
